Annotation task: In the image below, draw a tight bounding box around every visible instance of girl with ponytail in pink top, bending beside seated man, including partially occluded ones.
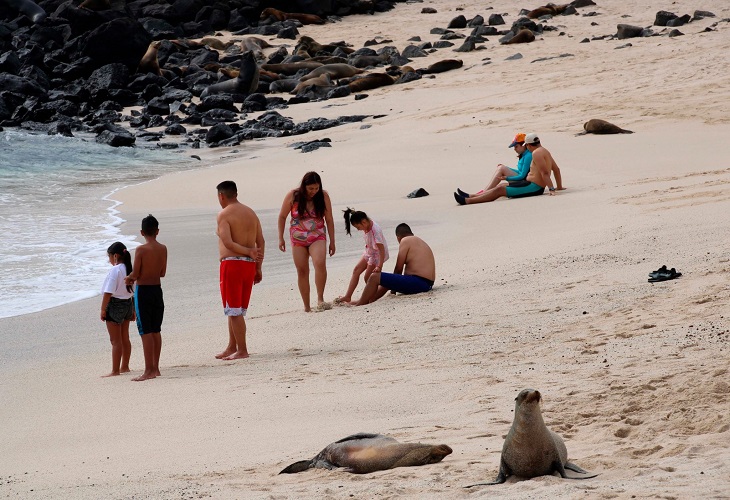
[335,207,389,304]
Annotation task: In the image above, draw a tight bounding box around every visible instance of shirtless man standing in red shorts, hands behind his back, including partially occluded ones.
[215,181,264,360]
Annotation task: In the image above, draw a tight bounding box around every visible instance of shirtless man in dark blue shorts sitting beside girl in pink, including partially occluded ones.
[354,223,436,306]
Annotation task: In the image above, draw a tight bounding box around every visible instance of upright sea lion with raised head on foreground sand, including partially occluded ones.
[466,389,598,488]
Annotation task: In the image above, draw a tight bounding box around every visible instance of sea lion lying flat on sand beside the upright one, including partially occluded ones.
[279,433,452,474]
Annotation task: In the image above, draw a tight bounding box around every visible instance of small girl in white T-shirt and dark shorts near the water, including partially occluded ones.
[100,241,135,377]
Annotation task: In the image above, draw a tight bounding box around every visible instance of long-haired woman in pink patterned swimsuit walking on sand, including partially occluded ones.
[279,172,335,312]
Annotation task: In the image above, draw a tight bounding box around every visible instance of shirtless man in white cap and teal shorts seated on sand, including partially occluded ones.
[454,133,565,205]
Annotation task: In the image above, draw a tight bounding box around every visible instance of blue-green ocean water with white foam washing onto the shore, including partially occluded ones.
[0,131,200,318]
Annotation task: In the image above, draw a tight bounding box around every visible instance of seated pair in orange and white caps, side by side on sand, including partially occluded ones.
[454,133,565,205]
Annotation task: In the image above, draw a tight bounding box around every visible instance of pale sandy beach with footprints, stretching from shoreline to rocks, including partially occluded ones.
[0,0,730,499]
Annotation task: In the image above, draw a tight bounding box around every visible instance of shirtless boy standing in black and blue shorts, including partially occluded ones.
[124,215,167,382]
